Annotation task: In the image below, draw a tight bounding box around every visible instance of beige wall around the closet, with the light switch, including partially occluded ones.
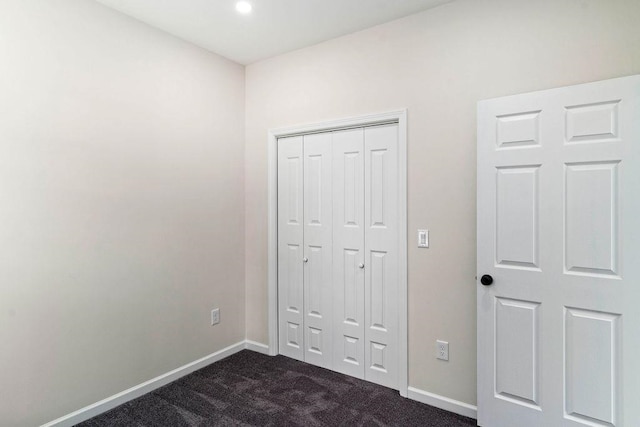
[245,0,640,404]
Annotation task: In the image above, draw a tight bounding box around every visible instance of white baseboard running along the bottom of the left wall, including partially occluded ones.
[41,341,245,427]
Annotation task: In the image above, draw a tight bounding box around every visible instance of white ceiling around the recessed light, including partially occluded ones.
[97,0,451,64]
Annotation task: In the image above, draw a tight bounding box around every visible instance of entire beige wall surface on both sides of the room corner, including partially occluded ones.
[0,0,640,426]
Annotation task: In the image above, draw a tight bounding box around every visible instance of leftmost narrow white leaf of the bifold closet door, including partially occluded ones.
[278,136,304,360]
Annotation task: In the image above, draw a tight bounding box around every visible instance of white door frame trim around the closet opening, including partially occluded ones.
[267,109,409,397]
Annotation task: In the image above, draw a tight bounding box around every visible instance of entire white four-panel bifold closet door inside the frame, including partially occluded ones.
[278,124,399,388]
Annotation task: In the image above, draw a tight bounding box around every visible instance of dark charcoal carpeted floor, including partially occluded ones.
[79,350,476,427]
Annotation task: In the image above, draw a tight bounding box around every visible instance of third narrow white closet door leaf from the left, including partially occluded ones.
[333,128,365,378]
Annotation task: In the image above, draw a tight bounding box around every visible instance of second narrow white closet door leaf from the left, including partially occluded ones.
[304,133,333,368]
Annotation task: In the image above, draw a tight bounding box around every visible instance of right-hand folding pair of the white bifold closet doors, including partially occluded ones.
[333,124,399,389]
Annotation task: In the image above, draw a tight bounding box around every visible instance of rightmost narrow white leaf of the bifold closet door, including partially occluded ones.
[364,124,399,389]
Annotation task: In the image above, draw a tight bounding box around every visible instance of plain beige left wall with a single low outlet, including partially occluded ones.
[0,0,245,426]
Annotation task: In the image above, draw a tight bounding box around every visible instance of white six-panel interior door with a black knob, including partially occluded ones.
[478,76,640,427]
